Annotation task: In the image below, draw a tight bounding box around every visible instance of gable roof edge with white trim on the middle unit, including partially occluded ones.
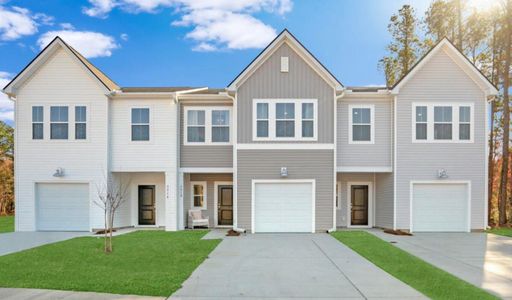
[227,29,344,91]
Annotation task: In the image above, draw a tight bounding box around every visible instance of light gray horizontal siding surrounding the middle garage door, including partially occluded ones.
[237,150,334,231]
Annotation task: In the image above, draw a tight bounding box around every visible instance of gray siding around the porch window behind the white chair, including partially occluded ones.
[183,174,233,227]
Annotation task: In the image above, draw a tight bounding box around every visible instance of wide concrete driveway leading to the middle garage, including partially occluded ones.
[171,234,425,300]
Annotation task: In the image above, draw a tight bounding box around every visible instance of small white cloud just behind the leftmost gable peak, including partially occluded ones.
[37,30,119,58]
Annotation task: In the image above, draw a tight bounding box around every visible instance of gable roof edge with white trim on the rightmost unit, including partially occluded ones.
[390,37,498,95]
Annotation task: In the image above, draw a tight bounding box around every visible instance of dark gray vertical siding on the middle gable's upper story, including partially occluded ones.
[237,44,334,143]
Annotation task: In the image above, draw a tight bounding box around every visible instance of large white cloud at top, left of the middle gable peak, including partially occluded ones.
[84,0,293,51]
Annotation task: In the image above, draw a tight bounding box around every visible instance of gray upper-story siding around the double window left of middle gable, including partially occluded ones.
[180,103,234,168]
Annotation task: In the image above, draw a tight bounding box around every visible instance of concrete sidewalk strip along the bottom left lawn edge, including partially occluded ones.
[0,288,165,300]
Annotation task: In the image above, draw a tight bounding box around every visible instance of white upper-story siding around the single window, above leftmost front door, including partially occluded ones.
[110,98,178,172]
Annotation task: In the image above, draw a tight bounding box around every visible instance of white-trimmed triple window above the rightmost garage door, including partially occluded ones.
[412,102,474,143]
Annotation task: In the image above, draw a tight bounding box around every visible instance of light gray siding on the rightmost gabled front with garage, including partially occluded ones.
[396,50,487,229]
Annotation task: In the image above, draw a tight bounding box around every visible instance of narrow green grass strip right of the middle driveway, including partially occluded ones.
[332,231,497,299]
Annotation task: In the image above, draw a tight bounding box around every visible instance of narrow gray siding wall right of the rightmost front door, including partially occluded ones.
[375,173,394,228]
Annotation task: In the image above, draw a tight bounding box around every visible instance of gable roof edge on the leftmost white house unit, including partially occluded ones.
[3,36,119,94]
